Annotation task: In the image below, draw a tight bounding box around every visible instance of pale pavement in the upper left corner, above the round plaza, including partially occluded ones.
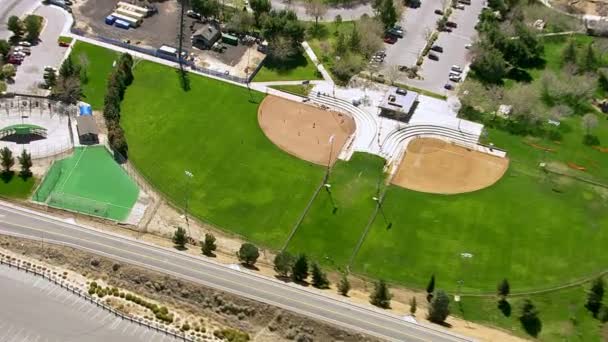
[9,5,69,95]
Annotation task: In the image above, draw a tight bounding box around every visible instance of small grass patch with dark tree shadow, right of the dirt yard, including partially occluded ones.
[253,52,322,82]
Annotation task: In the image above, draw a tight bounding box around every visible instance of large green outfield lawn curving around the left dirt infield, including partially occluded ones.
[121,62,324,248]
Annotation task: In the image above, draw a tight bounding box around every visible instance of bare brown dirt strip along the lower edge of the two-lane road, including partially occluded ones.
[0,236,377,341]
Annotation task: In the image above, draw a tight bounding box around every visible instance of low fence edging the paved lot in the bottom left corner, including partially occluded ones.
[0,257,196,342]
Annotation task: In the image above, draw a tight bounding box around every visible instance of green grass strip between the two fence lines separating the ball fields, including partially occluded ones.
[289,153,384,266]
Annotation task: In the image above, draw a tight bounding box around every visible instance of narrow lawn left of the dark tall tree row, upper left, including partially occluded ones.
[70,41,120,110]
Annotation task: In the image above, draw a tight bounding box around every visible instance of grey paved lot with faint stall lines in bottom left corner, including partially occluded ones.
[0,265,183,342]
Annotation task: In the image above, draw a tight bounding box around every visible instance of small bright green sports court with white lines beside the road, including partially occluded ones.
[34,146,139,221]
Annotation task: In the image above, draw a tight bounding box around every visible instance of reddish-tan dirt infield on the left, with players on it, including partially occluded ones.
[258,96,355,165]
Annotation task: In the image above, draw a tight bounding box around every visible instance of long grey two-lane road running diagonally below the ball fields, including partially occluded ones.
[0,202,470,341]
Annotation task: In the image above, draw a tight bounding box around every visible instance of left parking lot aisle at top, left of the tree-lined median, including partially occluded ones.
[384,0,442,69]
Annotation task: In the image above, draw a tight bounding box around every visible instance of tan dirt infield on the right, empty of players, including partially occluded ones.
[391,138,509,194]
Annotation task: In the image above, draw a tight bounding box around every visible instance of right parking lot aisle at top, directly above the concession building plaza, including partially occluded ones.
[398,0,485,94]
